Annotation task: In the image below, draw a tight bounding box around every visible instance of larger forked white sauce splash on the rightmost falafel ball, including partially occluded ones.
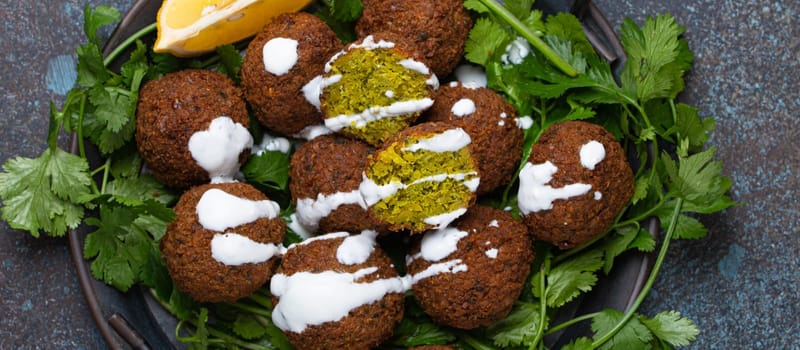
[517,161,592,214]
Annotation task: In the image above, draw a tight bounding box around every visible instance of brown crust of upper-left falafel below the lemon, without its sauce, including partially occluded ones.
[136,69,250,188]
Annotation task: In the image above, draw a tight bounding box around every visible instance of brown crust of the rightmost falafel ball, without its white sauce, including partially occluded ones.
[523,121,634,249]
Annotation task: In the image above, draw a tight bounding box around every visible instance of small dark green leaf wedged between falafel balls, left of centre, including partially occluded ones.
[247,151,291,190]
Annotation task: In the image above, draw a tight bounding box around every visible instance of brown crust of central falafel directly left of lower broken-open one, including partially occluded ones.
[289,135,387,233]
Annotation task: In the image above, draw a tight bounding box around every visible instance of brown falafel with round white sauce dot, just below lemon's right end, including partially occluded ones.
[240,12,342,136]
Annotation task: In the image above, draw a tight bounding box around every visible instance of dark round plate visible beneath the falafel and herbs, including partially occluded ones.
[69,0,659,349]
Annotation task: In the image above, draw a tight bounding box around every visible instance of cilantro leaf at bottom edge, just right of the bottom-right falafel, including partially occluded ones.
[486,302,547,347]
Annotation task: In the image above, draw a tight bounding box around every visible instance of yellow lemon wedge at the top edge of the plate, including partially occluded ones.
[153,0,311,57]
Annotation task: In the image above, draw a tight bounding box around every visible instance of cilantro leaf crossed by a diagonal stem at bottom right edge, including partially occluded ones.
[592,309,653,350]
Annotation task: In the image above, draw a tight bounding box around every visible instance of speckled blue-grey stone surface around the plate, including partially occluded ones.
[0,0,800,349]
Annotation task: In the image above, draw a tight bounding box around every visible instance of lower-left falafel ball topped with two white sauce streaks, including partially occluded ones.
[161,182,286,302]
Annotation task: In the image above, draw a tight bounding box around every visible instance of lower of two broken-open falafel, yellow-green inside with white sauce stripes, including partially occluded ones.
[359,122,480,233]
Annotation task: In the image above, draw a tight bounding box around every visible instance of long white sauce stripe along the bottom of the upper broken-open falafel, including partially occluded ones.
[325,98,433,131]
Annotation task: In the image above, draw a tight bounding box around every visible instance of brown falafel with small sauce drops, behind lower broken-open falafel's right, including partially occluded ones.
[425,83,524,195]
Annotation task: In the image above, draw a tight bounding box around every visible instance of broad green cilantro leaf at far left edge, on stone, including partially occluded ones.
[0,148,91,237]
